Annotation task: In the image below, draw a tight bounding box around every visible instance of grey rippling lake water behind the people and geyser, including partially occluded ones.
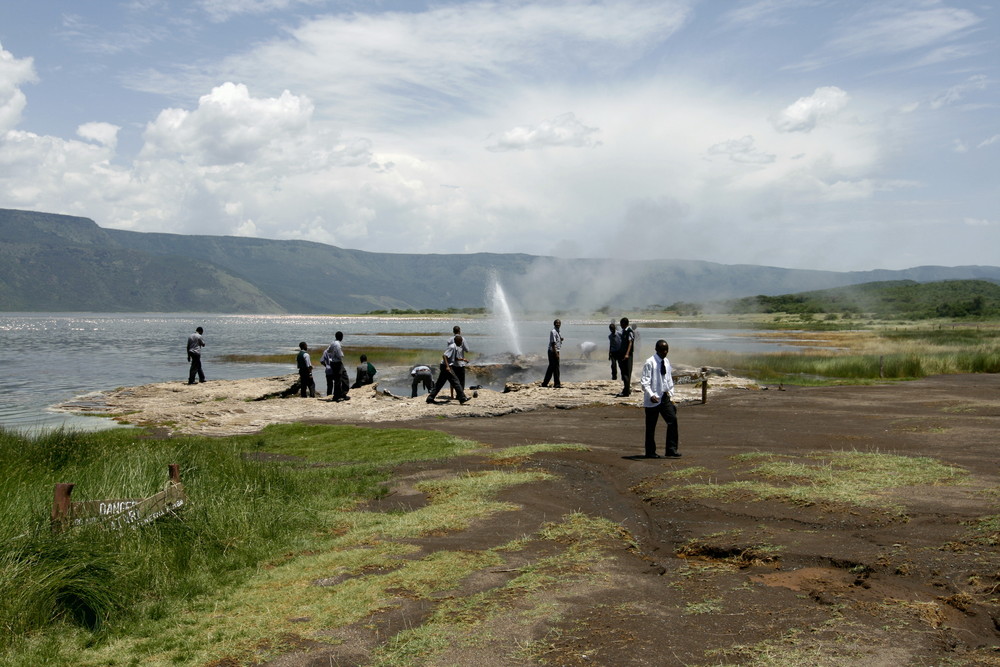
[0,313,796,430]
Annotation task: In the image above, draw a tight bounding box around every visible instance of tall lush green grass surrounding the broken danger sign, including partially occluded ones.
[0,425,474,664]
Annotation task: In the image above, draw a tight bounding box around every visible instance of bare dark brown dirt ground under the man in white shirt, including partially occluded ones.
[66,375,1000,667]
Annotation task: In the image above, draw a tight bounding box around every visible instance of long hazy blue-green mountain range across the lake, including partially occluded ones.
[0,209,1000,315]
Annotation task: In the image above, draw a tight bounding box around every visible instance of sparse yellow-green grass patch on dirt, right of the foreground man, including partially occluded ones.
[650,451,967,513]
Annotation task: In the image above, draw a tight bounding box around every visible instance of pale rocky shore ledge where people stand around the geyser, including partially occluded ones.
[56,373,760,436]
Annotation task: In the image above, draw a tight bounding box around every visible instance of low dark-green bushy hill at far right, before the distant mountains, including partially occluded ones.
[725,280,1000,319]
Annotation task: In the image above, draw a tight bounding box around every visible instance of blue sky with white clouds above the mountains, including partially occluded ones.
[0,0,1000,271]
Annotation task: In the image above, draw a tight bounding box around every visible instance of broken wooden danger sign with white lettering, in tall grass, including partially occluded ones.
[52,463,187,530]
